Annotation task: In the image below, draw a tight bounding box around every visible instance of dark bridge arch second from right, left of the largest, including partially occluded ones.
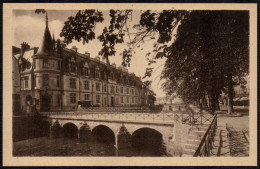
[91,125,116,145]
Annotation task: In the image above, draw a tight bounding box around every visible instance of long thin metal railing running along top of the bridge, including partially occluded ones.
[41,109,213,127]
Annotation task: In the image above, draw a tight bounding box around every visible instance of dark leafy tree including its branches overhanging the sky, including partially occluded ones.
[35,10,249,113]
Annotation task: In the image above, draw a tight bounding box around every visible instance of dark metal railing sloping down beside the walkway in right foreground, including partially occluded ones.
[193,114,217,157]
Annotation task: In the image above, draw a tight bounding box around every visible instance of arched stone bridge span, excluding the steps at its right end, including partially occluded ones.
[41,112,179,156]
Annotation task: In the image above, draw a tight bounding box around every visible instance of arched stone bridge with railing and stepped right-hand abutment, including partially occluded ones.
[38,110,212,155]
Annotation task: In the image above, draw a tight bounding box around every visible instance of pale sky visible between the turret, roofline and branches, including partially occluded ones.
[13,10,166,97]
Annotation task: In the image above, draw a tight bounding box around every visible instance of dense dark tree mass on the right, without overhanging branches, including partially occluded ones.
[159,11,249,113]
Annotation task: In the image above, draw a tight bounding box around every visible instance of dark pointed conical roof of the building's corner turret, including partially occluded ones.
[35,12,53,56]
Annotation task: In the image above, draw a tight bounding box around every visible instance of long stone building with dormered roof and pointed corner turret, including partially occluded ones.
[19,14,145,112]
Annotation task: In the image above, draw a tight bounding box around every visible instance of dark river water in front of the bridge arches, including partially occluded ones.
[13,137,168,157]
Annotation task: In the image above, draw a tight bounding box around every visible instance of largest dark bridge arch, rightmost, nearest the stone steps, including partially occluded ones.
[131,127,166,156]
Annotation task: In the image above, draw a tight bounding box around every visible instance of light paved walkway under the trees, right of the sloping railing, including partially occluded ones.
[212,108,249,157]
